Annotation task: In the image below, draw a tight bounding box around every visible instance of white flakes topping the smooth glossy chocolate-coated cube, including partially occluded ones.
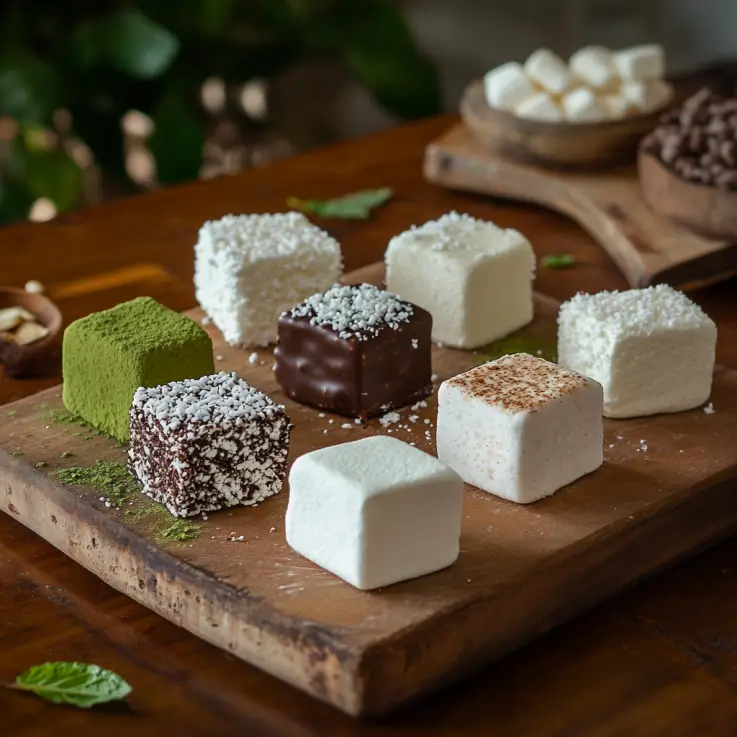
[288,284,412,340]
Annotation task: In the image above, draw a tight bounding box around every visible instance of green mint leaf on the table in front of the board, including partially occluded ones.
[12,662,132,709]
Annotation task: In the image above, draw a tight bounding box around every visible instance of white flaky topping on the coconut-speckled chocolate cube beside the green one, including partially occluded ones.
[132,371,284,432]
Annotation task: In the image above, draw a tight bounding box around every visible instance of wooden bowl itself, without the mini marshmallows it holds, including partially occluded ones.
[461,81,672,170]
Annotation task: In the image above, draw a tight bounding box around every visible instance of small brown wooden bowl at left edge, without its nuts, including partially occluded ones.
[0,287,62,379]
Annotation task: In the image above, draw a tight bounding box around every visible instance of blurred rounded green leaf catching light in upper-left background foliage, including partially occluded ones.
[105,9,179,79]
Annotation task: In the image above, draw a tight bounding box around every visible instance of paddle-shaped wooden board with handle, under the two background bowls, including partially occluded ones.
[425,125,737,289]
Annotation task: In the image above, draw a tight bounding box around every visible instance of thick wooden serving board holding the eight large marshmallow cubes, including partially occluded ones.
[0,265,737,715]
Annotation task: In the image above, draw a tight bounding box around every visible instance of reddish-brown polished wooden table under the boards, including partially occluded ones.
[0,117,737,737]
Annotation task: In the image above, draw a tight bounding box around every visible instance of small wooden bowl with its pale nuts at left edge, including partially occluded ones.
[0,287,62,378]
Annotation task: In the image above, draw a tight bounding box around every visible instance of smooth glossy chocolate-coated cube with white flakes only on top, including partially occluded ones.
[274,284,432,419]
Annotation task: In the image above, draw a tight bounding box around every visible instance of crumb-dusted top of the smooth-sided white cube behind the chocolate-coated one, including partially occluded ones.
[387,212,524,256]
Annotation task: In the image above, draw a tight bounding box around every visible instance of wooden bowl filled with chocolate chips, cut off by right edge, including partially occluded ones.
[638,89,737,240]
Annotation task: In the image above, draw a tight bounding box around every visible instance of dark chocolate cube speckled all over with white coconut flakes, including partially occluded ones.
[128,372,292,517]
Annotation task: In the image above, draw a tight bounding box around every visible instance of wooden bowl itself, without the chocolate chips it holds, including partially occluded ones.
[637,149,737,241]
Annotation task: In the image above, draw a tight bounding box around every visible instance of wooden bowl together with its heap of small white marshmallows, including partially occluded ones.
[461,44,673,168]
